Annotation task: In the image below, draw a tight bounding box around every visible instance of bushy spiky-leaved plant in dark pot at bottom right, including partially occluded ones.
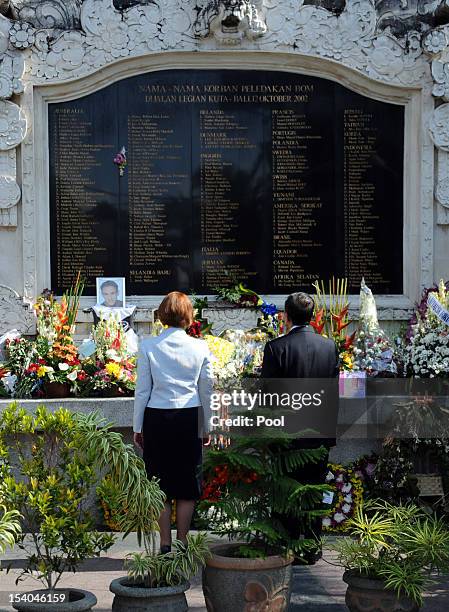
[331,501,449,612]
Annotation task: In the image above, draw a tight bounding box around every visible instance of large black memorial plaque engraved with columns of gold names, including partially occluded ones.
[49,70,404,295]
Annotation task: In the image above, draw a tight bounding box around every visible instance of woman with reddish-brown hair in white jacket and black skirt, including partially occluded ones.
[134,291,213,553]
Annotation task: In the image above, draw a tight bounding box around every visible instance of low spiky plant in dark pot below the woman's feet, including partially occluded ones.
[103,470,210,612]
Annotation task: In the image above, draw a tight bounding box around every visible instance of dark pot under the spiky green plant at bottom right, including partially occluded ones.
[343,571,419,612]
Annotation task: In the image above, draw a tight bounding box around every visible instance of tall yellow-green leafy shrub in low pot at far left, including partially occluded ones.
[0,403,114,612]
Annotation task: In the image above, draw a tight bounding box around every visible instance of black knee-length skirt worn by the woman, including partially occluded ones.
[142,406,203,500]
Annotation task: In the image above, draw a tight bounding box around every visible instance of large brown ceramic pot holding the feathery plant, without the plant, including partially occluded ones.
[203,544,293,612]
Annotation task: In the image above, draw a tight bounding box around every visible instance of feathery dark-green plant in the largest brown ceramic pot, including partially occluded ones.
[199,433,329,612]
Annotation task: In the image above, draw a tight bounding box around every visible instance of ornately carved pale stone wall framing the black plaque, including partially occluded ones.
[0,0,442,308]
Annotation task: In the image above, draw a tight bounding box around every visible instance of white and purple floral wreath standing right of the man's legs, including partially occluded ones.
[323,463,363,531]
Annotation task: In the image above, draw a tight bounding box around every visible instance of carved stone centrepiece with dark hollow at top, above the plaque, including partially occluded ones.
[193,0,267,45]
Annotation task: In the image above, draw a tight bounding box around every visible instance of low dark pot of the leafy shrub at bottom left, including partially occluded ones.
[12,589,97,612]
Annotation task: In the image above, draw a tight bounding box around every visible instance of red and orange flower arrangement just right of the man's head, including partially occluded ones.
[310,277,356,370]
